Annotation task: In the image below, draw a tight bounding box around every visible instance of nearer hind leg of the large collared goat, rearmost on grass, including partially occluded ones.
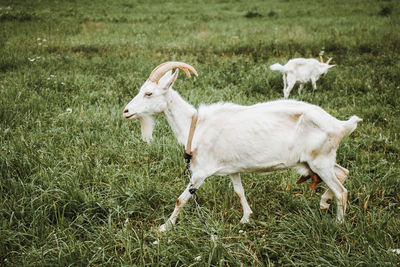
[309,160,347,223]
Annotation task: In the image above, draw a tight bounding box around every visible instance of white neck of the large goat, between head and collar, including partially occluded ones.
[164,88,197,145]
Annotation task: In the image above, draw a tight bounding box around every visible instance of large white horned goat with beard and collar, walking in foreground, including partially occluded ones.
[123,62,361,231]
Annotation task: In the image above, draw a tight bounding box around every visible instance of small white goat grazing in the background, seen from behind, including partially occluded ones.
[269,57,336,98]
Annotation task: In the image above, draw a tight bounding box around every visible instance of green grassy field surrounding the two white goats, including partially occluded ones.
[0,0,400,266]
